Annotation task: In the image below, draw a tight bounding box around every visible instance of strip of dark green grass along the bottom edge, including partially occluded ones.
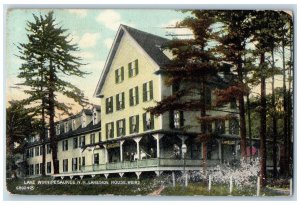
[7,177,286,196]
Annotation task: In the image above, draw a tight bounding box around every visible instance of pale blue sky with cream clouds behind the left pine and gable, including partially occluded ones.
[6,9,190,113]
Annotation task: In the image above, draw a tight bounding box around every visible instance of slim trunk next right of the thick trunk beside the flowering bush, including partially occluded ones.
[271,49,277,179]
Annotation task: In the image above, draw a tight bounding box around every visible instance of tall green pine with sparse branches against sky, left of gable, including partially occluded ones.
[18,12,87,174]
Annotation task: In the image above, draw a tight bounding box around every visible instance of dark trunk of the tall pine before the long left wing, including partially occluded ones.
[48,59,59,174]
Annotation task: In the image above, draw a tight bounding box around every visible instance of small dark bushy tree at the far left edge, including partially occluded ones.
[6,101,35,178]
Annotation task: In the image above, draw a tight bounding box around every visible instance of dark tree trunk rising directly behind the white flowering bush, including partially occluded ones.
[237,55,246,159]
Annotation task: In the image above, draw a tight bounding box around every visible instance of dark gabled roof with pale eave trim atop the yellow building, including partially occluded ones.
[94,24,169,97]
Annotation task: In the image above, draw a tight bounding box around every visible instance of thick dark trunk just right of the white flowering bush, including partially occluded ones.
[259,53,267,187]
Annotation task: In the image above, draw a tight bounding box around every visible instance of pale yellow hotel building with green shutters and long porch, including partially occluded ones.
[26,25,272,178]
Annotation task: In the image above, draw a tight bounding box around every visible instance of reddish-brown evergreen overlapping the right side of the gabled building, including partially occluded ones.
[147,10,231,175]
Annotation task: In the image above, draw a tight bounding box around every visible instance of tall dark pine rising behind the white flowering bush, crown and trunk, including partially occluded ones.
[217,10,251,158]
